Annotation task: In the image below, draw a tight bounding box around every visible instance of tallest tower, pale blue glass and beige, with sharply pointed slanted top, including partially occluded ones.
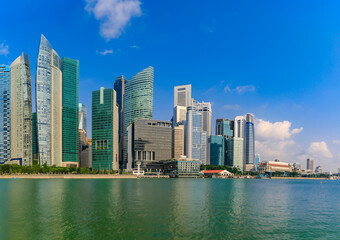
[35,35,62,166]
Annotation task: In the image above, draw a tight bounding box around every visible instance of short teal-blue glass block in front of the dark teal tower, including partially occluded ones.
[209,136,226,166]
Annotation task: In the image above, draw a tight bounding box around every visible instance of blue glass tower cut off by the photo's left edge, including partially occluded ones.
[0,65,11,164]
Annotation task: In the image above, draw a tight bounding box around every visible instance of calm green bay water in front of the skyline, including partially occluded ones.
[0,179,340,239]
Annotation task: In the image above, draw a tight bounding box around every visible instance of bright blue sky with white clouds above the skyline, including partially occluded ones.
[0,0,340,171]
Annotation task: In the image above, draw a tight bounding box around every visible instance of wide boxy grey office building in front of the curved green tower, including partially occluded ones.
[127,119,172,170]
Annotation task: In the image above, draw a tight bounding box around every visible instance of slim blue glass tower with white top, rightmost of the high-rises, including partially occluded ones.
[244,113,255,164]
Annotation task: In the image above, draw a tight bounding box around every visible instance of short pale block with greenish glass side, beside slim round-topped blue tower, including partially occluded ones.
[227,137,244,171]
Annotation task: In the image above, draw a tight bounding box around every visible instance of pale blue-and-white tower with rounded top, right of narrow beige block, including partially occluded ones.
[185,106,210,165]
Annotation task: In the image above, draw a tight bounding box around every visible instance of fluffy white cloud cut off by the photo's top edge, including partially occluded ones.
[85,0,142,40]
